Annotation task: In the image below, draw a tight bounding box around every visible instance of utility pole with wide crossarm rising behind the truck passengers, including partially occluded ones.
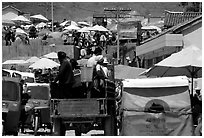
[104,7,131,64]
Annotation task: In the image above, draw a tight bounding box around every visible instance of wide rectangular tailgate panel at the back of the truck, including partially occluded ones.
[51,98,107,118]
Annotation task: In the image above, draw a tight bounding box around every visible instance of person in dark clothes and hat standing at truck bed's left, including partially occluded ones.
[54,51,75,99]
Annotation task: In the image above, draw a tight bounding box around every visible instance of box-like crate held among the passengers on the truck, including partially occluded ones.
[81,67,93,82]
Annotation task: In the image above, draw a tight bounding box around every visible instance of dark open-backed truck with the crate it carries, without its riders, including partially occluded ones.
[50,67,117,136]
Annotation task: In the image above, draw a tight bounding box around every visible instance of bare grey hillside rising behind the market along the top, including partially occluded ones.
[2,2,182,21]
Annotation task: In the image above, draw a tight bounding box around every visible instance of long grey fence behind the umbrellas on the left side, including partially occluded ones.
[2,39,76,61]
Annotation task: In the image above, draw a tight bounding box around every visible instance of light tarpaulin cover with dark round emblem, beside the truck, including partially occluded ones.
[121,77,193,136]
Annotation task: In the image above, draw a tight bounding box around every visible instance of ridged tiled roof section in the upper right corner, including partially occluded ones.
[164,11,202,28]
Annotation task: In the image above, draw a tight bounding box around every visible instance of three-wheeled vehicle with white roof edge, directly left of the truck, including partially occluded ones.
[24,83,52,135]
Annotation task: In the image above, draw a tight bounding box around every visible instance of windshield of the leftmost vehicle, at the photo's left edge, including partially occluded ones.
[2,81,19,101]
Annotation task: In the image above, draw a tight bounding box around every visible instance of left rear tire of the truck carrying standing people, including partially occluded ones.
[53,118,66,136]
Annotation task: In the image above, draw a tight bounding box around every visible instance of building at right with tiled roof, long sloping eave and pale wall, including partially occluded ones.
[136,12,202,68]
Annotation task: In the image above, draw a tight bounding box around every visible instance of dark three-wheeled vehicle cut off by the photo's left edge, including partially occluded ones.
[2,77,23,136]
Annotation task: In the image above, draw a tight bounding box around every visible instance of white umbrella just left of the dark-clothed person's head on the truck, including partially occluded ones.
[29,58,60,69]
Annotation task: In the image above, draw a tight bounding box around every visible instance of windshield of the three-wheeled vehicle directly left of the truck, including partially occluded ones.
[27,86,49,100]
